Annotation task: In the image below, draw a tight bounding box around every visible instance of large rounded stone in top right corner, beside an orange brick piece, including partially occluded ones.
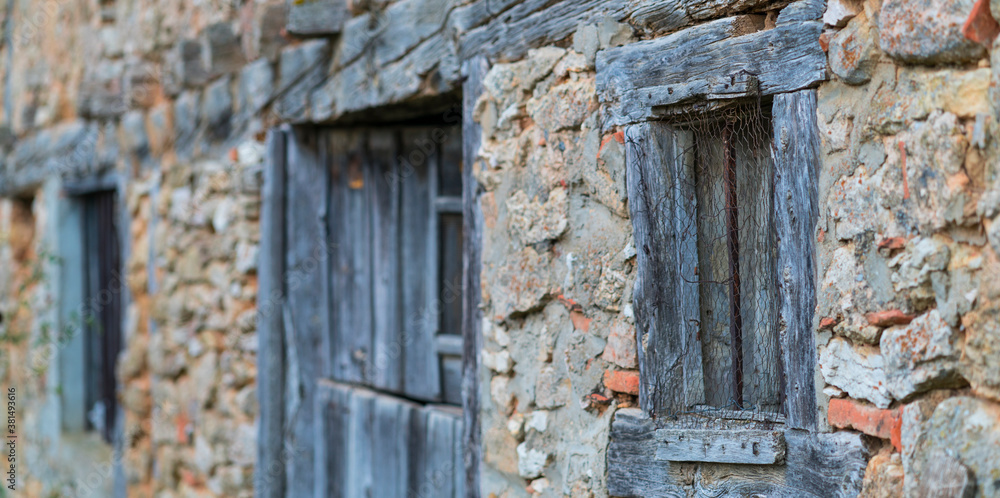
[879,0,986,65]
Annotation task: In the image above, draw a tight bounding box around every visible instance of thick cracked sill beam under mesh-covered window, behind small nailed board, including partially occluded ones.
[608,409,868,497]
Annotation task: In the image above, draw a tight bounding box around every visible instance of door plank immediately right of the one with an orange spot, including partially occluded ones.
[368,130,403,392]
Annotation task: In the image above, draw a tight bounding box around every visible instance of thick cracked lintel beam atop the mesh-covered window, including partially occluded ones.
[597,16,826,124]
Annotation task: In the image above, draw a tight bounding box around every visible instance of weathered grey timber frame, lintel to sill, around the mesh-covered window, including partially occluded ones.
[597,0,867,496]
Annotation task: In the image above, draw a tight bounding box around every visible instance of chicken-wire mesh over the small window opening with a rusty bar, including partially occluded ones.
[671,102,783,424]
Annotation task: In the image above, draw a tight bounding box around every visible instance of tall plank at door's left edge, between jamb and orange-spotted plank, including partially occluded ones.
[285,129,329,496]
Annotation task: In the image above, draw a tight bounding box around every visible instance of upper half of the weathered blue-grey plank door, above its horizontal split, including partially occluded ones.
[324,127,462,404]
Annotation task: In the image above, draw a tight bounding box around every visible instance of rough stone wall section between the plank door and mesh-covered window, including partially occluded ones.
[476,40,639,496]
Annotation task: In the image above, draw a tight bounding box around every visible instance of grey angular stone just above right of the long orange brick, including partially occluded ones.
[879,310,961,399]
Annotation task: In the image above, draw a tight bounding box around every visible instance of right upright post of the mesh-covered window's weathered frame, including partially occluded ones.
[772,90,819,430]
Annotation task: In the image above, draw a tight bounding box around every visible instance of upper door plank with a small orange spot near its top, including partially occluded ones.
[329,131,372,383]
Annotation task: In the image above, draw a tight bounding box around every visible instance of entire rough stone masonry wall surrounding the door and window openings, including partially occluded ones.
[0,0,1000,497]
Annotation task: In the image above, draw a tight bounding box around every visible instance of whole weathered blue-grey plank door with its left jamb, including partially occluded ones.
[257,126,465,497]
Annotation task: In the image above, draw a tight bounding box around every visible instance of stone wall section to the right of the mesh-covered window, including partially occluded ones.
[816,0,1000,496]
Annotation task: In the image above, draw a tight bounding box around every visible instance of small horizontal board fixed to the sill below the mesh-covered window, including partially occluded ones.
[654,429,785,465]
